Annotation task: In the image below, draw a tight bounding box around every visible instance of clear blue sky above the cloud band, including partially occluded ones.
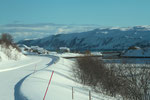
[0,0,150,27]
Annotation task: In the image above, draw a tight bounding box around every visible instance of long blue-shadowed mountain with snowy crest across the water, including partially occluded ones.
[19,26,150,51]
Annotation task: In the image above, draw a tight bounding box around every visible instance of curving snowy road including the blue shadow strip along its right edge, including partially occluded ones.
[0,56,57,100]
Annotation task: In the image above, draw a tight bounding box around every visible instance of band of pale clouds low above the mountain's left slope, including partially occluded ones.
[0,23,100,41]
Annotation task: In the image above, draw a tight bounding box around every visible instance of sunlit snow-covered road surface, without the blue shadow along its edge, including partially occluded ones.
[0,56,52,100]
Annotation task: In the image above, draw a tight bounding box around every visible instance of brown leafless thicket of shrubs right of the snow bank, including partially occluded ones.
[73,56,150,100]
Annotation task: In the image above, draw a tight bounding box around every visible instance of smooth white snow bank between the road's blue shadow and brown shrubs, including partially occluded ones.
[21,58,115,100]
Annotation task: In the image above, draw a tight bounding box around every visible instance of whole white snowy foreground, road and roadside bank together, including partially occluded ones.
[0,55,115,100]
